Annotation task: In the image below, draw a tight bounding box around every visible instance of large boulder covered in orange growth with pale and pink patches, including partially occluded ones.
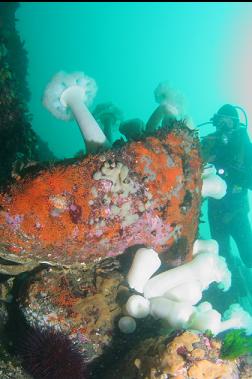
[0,123,202,265]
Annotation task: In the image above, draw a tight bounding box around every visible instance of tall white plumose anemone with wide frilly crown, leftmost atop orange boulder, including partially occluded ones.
[43,71,109,152]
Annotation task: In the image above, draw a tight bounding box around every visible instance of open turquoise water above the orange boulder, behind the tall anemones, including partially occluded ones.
[16,2,252,158]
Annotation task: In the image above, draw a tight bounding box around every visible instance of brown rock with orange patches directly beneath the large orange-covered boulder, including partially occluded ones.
[17,259,126,362]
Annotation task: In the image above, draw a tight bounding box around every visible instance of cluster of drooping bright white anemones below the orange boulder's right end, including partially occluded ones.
[119,240,252,335]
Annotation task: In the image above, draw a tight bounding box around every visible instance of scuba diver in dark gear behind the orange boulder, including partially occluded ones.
[201,104,252,268]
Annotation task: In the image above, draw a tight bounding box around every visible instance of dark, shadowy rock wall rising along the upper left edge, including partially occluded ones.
[0,2,56,188]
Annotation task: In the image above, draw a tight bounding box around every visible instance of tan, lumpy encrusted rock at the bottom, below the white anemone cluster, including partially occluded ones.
[105,331,239,379]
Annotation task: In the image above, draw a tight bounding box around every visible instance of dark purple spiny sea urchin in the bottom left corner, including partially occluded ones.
[20,328,86,379]
